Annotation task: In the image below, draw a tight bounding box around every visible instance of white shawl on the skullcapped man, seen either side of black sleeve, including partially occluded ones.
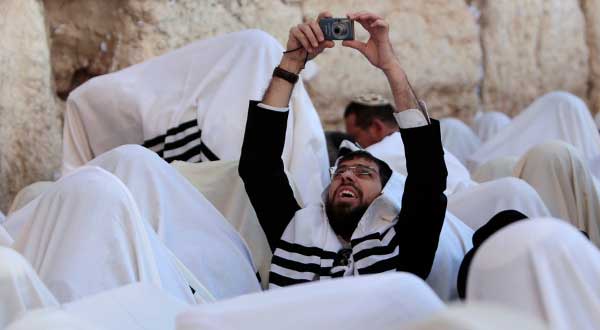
[366,132,475,195]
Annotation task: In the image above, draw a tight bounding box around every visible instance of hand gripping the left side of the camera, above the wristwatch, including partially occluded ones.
[282,12,335,73]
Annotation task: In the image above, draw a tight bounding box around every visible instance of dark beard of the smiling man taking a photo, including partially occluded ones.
[325,199,369,242]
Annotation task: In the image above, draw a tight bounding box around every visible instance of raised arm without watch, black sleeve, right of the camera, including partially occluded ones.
[344,12,448,279]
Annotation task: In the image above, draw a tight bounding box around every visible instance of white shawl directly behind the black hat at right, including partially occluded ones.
[448,178,551,230]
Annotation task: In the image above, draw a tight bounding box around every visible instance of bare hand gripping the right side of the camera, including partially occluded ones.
[342,12,400,72]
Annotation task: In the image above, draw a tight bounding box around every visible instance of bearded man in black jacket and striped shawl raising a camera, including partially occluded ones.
[239,12,447,287]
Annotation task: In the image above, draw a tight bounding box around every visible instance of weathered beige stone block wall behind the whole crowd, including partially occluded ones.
[0,0,600,210]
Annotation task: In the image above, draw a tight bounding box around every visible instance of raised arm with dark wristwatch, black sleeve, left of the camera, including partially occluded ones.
[239,13,333,250]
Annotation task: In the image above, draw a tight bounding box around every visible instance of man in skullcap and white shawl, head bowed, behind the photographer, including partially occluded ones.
[344,94,475,195]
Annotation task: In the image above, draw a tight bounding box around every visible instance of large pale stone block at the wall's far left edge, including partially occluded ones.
[0,0,62,211]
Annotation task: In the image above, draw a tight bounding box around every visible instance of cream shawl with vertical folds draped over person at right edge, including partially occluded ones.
[514,141,600,246]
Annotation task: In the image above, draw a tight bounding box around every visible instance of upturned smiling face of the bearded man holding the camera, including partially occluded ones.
[328,158,382,213]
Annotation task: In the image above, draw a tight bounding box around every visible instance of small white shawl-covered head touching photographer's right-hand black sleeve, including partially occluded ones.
[440,118,481,166]
